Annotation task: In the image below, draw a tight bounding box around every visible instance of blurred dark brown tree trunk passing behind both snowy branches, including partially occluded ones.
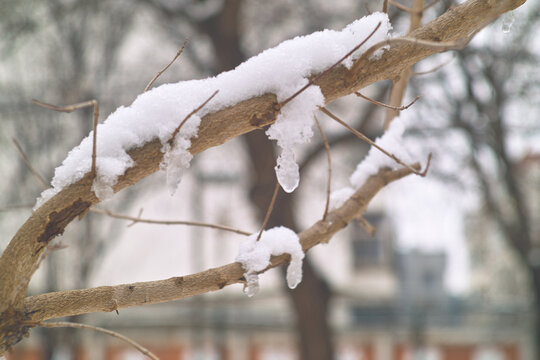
[199,0,333,360]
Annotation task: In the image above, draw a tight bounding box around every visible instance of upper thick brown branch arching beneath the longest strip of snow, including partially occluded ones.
[0,0,525,326]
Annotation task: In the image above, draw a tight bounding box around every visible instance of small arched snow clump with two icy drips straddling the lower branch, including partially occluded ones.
[236,226,304,297]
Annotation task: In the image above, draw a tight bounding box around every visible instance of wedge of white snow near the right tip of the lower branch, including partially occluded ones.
[350,117,413,190]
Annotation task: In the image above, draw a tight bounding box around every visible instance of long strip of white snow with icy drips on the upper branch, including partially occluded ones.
[36,13,391,208]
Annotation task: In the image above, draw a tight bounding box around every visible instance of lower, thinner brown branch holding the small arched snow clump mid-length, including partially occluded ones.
[24,165,411,322]
